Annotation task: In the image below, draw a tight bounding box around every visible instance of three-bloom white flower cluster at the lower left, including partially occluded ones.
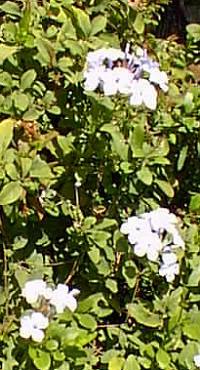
[20,279,80,342]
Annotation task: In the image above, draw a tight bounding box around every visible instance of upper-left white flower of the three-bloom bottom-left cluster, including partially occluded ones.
[22,279,46,304]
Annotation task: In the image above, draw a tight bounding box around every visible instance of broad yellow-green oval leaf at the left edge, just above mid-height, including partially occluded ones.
[0,181,23,206]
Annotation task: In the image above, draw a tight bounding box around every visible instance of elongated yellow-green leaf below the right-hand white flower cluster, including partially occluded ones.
[128,303,162,328]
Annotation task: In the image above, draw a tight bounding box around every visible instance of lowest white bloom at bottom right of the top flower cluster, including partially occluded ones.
[130,78,157,110]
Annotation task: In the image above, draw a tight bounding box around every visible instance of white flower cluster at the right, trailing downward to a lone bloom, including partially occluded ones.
[121,208,185,282]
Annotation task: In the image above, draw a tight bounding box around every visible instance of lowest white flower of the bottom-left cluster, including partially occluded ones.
[19,311,49,342]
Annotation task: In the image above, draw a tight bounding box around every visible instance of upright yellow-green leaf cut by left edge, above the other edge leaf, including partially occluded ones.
[0,118,15,157]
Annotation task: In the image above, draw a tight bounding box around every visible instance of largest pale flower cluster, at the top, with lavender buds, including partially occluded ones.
[84,45,168,110]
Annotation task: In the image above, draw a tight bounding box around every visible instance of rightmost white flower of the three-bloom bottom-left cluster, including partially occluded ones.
[50,284,79,313]
